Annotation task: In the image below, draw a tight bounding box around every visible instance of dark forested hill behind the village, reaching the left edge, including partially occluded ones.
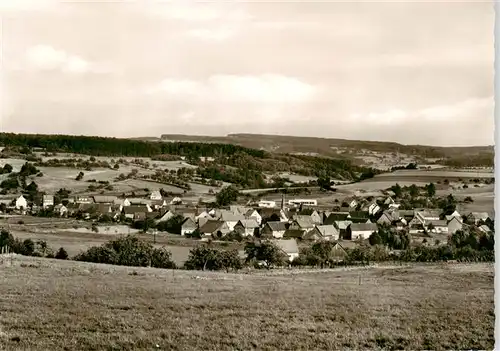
[0,133,380,181]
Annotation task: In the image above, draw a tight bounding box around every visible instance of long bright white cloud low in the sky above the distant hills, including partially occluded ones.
[148,74,318,104]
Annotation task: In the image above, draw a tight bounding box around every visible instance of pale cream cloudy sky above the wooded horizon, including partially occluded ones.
[0,0,494,146]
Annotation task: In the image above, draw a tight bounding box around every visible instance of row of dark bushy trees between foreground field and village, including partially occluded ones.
[0,231,494,272]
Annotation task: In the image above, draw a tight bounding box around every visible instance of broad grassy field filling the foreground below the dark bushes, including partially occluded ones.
[0,256,494,350]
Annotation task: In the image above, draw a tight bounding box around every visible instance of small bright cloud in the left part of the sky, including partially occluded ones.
[26,45,108,74]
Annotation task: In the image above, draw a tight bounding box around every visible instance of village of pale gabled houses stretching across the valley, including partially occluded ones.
[0,191,493,261]
